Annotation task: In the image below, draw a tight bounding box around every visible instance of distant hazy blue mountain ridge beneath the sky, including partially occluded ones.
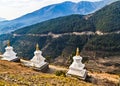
[0,0,115,34]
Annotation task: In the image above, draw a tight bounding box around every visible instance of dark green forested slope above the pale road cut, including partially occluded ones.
[14,1,120,34]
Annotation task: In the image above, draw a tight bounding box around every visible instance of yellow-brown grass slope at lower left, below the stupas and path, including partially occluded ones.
[0,61,94,86]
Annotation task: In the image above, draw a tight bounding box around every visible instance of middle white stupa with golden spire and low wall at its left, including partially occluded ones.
[21,44,48,71]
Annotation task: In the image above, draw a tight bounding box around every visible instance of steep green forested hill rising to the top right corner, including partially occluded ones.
[91,1,120,32]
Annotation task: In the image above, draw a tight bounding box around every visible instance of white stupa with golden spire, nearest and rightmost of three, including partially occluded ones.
[66,48,87,80]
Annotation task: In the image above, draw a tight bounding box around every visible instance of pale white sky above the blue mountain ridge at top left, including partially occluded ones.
[0,0,100,20]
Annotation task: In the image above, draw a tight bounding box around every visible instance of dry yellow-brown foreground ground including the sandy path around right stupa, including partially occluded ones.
[0,61,120,86]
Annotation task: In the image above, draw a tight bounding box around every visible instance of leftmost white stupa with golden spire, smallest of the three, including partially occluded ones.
[1,40,18,61]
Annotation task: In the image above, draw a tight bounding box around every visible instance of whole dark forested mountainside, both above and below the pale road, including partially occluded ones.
[0,1,120,64]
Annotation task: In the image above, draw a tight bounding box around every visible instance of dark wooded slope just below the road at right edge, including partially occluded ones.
[85,34,120,55]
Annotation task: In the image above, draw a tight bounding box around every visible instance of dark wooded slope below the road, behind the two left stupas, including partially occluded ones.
[0,35,88,59]
